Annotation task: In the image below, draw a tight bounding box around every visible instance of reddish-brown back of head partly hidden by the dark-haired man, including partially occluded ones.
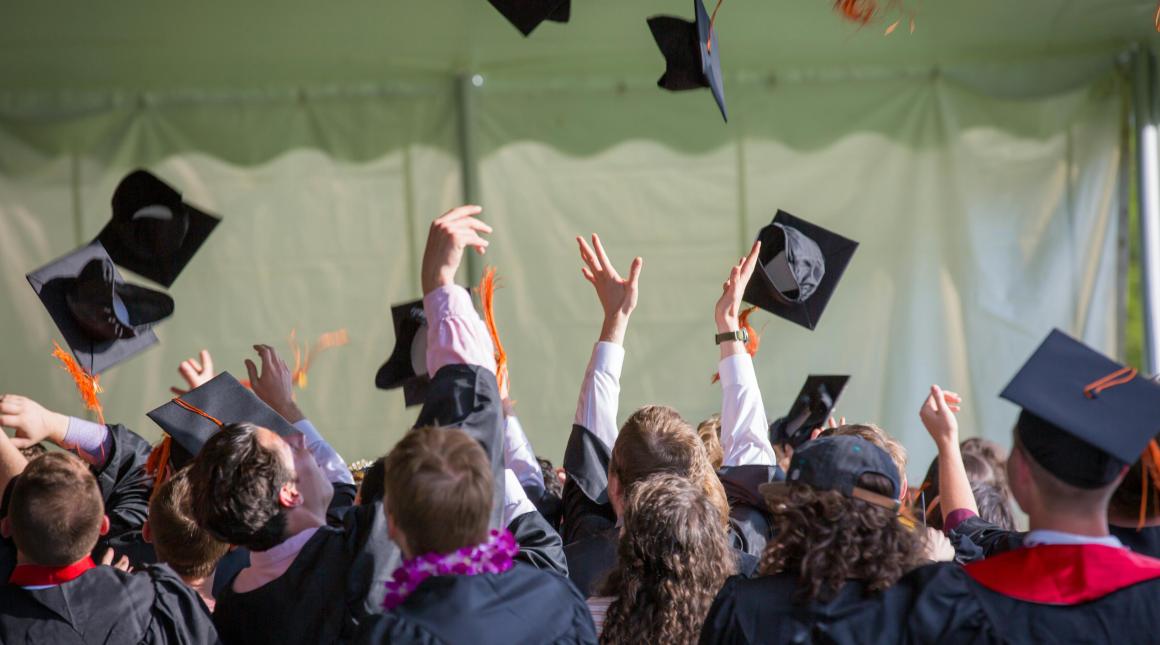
[148,466,230,580]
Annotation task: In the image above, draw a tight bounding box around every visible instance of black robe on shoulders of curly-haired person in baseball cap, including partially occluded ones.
[701,574,905,645]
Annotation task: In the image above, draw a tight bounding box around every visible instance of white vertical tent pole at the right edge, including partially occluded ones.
[1132,44,1160,374]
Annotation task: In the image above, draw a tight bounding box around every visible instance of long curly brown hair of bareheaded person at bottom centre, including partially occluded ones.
[600,473,734,644]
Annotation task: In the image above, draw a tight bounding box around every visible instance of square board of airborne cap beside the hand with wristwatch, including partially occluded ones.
[745,210,858,329]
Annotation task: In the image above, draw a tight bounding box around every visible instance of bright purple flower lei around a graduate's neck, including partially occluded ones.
[383,529,520,611]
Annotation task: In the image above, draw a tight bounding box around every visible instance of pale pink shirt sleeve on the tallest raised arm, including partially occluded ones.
[423,284,495,376]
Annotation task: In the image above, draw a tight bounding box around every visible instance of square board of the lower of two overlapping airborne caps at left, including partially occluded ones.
[26,242,158,375]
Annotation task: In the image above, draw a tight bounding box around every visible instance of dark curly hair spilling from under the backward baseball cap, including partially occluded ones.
[760,473,923,603]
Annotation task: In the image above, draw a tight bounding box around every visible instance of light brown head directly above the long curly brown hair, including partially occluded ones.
[608,405,728,522]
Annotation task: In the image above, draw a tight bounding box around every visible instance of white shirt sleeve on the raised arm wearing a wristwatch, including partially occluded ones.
[718,354,777,466]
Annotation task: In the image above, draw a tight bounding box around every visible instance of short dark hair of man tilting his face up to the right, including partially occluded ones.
[189,423,293,551]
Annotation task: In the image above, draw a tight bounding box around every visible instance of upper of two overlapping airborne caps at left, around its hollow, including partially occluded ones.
[96,171,222,288]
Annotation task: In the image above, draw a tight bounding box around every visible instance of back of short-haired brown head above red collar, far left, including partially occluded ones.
[8,452,104,566]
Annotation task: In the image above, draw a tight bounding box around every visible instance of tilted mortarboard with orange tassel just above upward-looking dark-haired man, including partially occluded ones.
[147,371,299,470]
